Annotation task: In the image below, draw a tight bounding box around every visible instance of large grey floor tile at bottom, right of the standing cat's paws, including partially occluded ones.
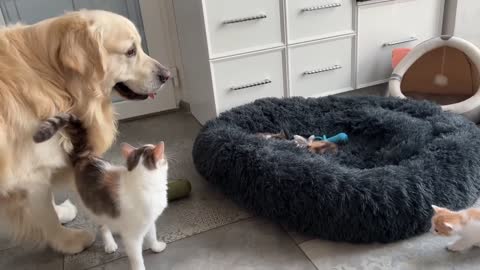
[88,218,315,270]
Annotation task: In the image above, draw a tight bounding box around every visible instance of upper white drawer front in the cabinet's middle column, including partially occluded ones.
[287,0,353,43]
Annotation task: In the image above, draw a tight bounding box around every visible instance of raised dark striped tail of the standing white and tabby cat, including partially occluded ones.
[33,113,91,165]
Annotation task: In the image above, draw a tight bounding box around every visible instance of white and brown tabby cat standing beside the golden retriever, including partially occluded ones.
[33,114,168,270]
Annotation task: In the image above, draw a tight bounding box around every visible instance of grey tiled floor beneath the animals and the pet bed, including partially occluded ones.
[0,85,480,270]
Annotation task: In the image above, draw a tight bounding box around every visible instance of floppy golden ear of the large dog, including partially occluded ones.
[58,17,105,80]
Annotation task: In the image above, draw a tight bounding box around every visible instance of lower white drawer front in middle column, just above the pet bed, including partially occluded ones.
[289,37,353,97]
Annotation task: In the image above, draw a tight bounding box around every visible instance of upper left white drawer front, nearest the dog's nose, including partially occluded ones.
[204,0,283,58]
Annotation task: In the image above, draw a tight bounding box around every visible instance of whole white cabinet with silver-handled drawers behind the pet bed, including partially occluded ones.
[174,0,443,123]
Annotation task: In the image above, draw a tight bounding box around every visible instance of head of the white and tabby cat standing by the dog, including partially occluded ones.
[122,142,168,171]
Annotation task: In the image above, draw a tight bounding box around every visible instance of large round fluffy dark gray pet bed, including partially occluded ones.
[193,97,480,242]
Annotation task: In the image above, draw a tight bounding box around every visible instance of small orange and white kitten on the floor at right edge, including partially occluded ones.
[432,205,480,251]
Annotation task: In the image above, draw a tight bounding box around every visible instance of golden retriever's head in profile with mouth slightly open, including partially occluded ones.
[47,10,170,100]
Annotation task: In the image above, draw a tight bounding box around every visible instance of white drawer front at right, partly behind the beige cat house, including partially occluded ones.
[358,0,443,87]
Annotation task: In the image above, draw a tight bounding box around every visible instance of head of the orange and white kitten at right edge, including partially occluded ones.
[431,205,463,236]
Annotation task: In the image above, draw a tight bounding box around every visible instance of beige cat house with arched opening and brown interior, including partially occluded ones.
[388,36,480,122]
